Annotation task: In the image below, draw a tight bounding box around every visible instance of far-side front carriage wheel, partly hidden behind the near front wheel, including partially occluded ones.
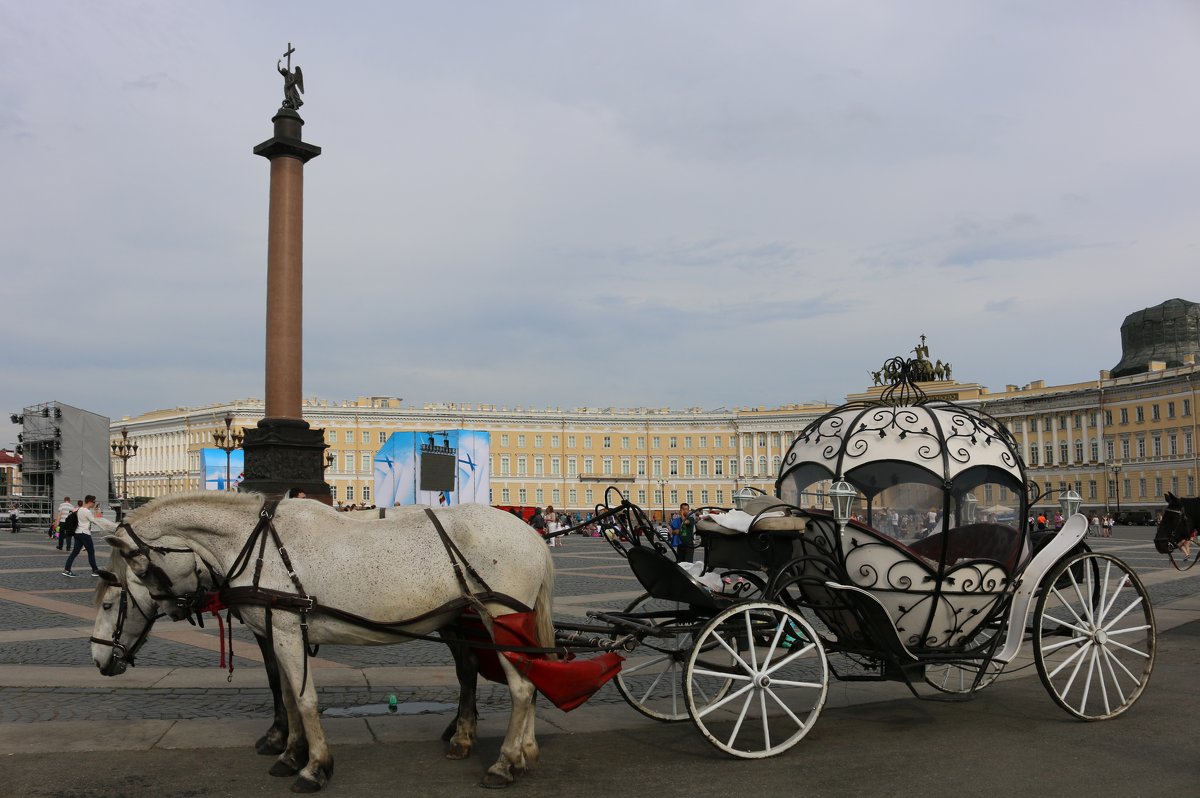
[613,593,731,722]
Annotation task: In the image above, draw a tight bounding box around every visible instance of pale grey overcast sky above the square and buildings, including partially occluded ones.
[0,0,1200,444]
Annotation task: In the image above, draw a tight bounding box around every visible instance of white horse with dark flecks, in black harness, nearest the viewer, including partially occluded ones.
[92,493,553,792]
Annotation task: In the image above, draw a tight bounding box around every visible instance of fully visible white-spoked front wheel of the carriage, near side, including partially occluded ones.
[684,601,829,758]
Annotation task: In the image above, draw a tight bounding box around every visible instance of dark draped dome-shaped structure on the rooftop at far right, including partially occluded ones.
[1112,299,1200,377]
